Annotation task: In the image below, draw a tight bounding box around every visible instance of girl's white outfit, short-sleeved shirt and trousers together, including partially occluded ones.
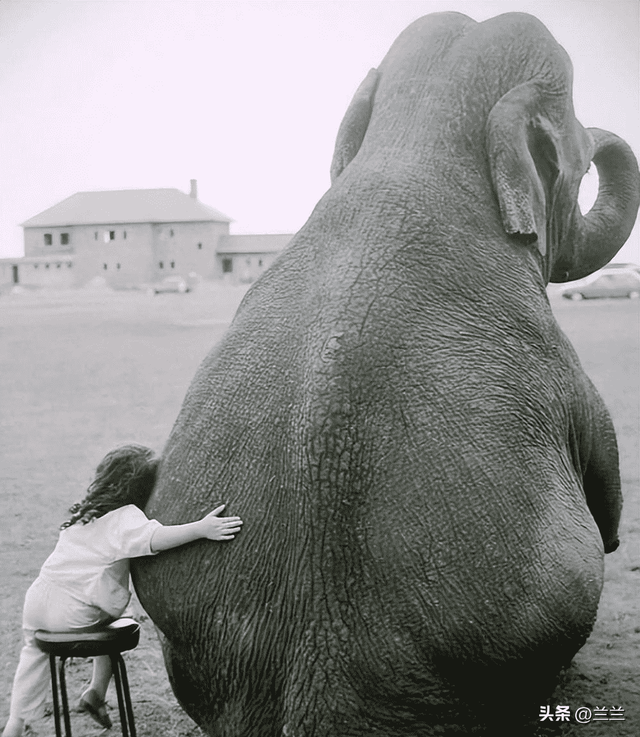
[11,504,162,722]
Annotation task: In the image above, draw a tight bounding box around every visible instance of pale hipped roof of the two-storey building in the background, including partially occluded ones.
[22,189,231,228]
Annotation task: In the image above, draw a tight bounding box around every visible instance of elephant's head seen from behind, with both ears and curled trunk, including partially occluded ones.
[331,13,640,282]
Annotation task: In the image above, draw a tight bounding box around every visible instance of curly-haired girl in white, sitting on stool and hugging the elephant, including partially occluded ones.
[2,445,242,737]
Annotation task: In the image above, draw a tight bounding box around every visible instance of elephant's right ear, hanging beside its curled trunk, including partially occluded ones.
[486,82,559,256]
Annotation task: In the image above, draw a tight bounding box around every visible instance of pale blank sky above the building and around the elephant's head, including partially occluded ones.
[0,0,640,263]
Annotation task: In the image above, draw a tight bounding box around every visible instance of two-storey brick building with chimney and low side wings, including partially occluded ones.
[0,180,291,288]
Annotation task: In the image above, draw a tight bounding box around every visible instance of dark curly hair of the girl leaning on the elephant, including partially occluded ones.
[60,443,158,530]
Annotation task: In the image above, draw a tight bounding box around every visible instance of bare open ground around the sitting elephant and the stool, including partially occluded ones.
[0,284,640,737]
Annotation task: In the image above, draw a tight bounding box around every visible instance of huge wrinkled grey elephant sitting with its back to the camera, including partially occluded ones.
[132,12,640,737]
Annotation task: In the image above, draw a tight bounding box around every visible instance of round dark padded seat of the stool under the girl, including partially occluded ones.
[35,618,140,658]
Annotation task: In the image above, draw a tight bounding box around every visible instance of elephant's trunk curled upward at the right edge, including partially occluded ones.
[551,128,640,282]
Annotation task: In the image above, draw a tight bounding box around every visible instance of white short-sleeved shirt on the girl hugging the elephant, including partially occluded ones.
[40,504,162,617]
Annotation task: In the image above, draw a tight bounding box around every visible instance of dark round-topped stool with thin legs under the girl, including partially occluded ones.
[35,619,140,737]
